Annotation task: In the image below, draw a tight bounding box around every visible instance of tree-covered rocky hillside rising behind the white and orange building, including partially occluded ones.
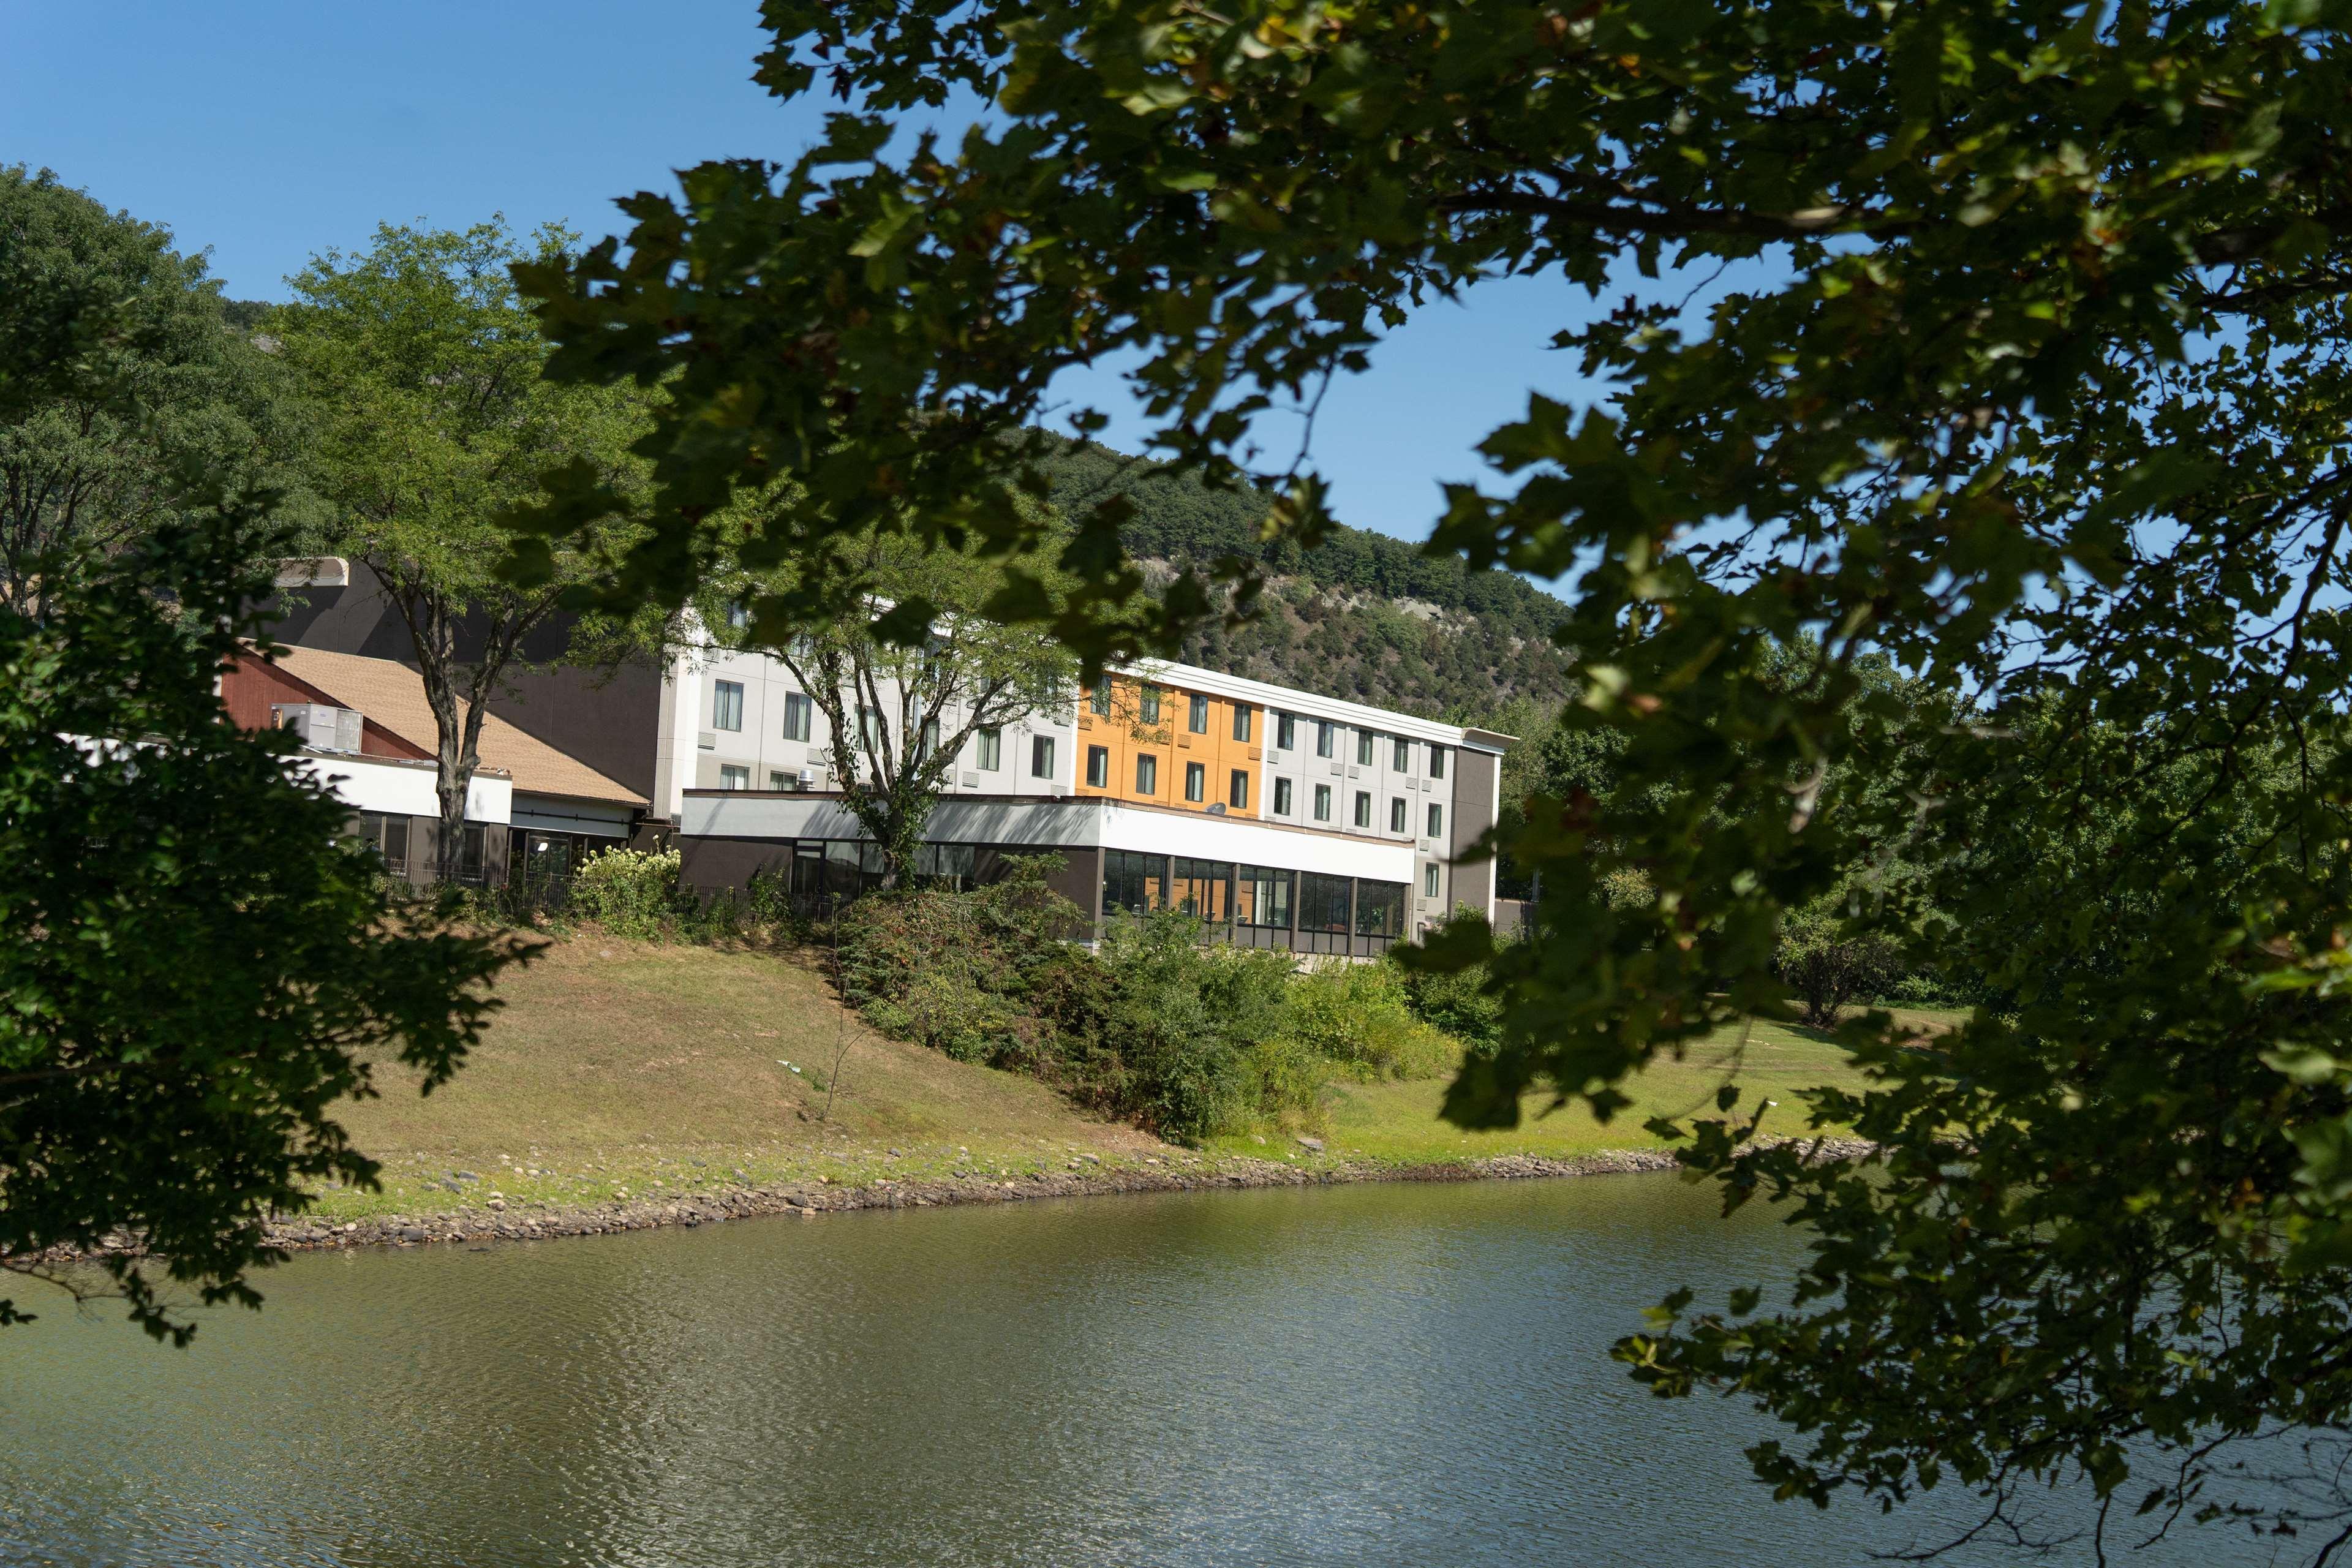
[1047,442,1569,719]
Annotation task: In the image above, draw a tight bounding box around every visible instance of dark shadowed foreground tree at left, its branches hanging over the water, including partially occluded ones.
[0,263,513,1343]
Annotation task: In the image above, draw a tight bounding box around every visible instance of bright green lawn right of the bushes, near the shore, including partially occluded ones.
[1218,1009,1966,1164]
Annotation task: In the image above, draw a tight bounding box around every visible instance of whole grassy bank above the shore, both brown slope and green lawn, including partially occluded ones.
[308,933,1891,1218]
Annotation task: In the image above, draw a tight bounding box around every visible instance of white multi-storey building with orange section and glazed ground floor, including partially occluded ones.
[654,649,1510,957]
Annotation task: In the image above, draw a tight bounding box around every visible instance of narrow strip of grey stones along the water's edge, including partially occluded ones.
[268,1138,1870,1251]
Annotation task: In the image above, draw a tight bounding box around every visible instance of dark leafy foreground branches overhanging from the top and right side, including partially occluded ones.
[527,0,2352,1556]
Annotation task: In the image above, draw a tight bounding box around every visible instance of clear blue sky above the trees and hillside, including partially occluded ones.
[0,0,1585,554]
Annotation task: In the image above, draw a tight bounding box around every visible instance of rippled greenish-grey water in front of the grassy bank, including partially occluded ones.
[0,1175,2270,1568]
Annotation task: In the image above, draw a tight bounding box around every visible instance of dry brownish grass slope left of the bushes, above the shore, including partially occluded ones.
[325,936,1169,1213]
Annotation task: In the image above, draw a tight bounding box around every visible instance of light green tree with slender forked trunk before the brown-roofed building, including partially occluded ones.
[266,224,658,877]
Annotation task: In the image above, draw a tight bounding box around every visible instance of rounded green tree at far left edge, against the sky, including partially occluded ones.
[0,165,299,614]
